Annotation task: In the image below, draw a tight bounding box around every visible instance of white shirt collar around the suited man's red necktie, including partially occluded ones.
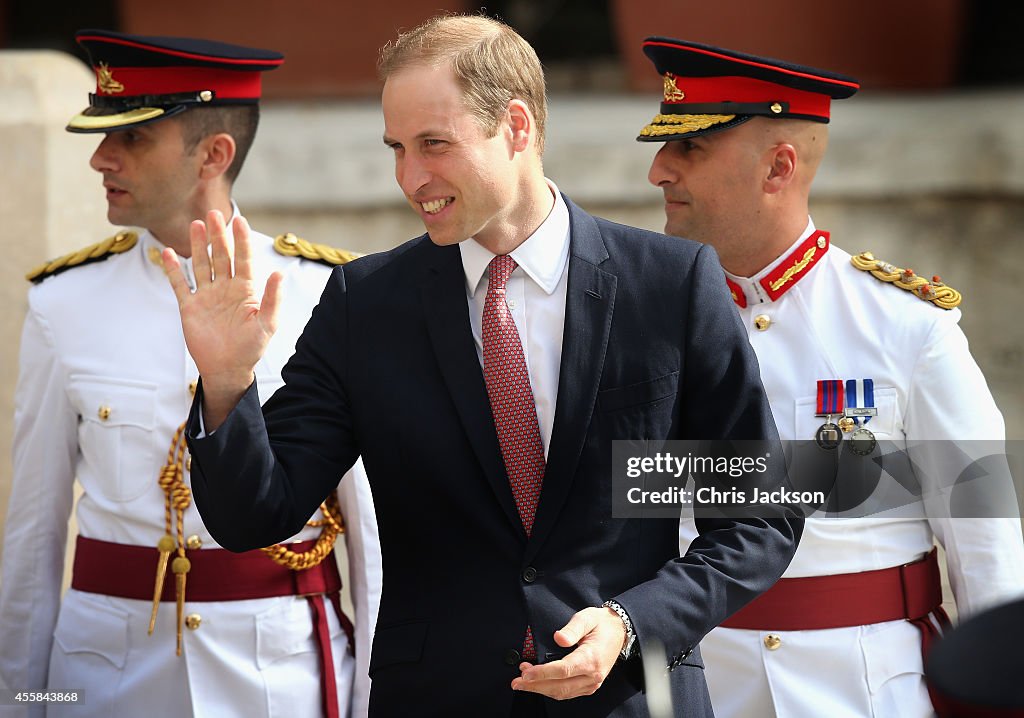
[459,179,569,297]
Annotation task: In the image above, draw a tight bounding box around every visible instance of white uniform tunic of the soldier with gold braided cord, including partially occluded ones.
[0,220,380,718]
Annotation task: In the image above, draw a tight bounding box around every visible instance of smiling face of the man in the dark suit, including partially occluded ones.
[382,65,543,251]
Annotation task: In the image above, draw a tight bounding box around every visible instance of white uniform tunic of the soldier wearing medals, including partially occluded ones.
[681,218,1024,718]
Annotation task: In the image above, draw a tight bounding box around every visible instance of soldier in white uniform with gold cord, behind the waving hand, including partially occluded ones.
[0,31,380,718]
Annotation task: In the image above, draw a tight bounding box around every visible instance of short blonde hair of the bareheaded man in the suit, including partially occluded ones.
[377,15,548,154]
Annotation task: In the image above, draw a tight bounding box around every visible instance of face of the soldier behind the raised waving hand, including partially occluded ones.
[89,118,202,237]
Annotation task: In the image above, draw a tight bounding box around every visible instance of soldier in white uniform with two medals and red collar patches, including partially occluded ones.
[638,38,1024,718]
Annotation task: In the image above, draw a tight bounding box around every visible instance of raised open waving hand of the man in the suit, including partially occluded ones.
[163,210,282,431]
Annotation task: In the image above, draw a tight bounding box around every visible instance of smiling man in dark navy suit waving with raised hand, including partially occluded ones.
[165,16,802,716]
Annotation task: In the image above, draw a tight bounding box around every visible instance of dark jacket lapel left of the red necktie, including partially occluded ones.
[421,246,526,540]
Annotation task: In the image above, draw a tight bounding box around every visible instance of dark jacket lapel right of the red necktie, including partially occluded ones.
[528,198,617,561]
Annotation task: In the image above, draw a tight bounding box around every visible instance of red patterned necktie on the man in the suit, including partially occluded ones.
[482,255,545,661]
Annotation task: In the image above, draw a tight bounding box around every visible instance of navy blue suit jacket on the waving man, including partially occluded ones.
[189,195,802,716]
